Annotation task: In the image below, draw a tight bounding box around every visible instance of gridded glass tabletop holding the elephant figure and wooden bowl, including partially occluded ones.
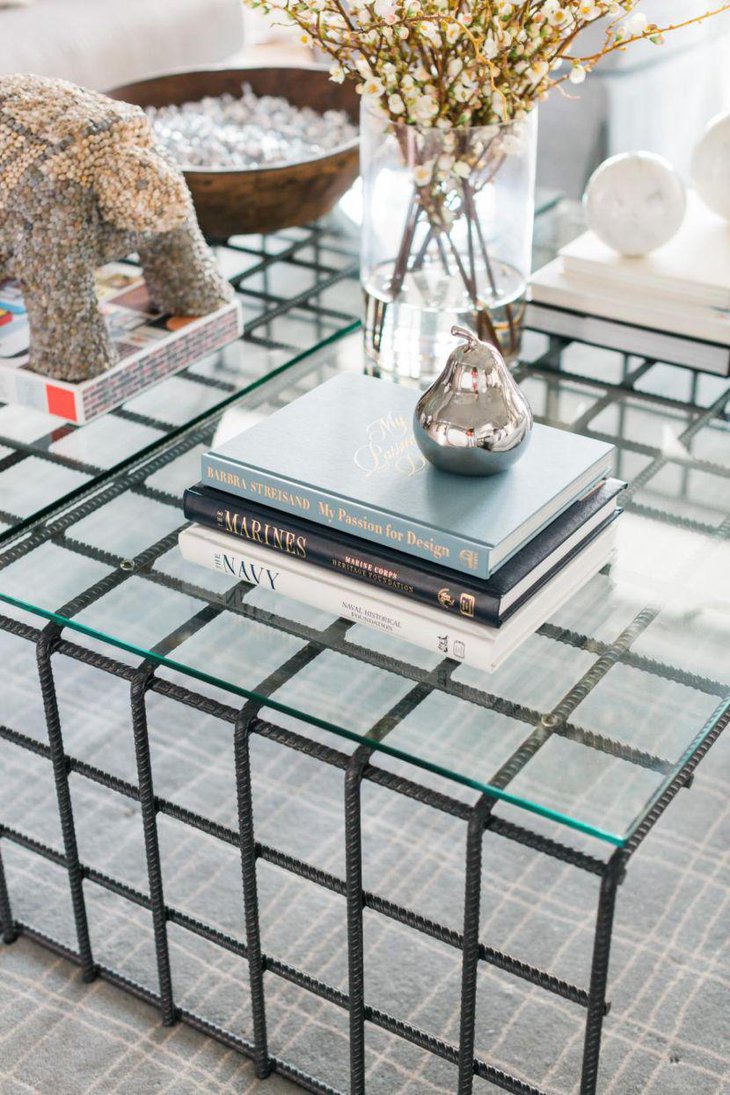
[0,224,359,540]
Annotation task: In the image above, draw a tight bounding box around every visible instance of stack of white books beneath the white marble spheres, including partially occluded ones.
[526,193,730,377]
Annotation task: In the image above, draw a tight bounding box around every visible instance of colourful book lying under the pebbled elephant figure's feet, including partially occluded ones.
[0,263,243,424]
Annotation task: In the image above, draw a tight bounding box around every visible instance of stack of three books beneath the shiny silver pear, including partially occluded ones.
[179,373,625,670]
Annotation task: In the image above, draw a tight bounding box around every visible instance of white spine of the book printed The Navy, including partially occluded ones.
[178,526,494,669]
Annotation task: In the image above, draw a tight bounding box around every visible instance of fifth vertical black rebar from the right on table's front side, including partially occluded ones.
[130,661,177,1026]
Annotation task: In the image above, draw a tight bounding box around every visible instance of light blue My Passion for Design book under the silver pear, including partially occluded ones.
[202,373,613,578]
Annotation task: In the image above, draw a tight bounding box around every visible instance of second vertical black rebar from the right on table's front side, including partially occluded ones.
[457,796,494,1095]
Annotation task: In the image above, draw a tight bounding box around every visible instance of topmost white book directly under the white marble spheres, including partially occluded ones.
[559,192,730,309]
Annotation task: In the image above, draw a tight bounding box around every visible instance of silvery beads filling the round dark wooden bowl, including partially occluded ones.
[147,83,358,169]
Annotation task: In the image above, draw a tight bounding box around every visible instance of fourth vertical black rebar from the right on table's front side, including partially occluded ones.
[233,703,271,1080]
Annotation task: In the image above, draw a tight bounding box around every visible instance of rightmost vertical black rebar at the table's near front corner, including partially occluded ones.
[580,848,627,1095]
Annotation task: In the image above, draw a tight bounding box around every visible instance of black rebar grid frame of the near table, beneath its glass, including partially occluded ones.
[0,319,730,1095]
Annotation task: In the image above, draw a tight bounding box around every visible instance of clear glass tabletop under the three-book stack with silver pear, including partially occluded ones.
[0,317,730,845]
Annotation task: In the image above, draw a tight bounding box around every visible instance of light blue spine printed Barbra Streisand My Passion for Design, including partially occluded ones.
[201,452,490,578]
